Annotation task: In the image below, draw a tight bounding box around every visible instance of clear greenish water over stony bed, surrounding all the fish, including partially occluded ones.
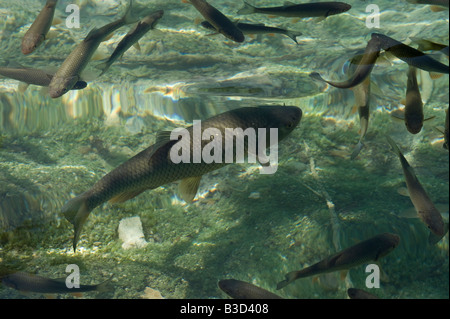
[0,0,449,298]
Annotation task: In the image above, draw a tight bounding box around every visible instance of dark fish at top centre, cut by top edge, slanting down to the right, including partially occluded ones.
[184,0,245,42]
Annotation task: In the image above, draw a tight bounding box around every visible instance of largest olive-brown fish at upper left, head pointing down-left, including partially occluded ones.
[49,0,136,99]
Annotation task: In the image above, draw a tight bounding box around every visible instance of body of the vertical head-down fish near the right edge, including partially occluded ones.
[405,66,424,134]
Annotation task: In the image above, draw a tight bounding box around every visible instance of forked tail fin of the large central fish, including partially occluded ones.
[61,192,91,251]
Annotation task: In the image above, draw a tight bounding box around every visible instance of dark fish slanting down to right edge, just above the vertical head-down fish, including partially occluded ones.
[372,33,449,74]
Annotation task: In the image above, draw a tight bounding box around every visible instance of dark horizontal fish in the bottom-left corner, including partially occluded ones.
[0,271,111,294]
